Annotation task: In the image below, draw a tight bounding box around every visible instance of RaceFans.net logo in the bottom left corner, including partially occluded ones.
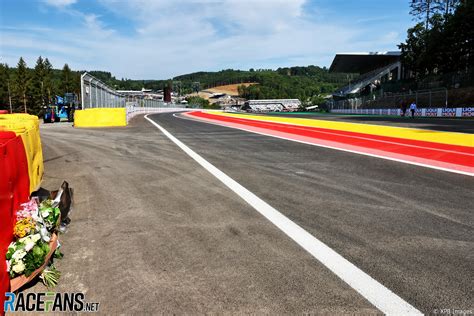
[3,292,100,312]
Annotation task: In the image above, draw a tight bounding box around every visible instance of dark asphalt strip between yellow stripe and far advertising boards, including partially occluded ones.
[265,111,474,134]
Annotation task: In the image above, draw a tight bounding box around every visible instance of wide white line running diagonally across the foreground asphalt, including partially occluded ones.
[145,115,423,315]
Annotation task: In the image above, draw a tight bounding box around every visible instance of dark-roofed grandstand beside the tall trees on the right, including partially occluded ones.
[325,51,474,110]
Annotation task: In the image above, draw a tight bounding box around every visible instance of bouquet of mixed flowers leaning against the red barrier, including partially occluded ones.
[6,198,60,278]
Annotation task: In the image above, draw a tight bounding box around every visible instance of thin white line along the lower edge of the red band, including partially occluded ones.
[173,113,474,177]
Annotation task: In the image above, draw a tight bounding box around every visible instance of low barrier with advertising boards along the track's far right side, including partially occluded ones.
[331,107,474,117]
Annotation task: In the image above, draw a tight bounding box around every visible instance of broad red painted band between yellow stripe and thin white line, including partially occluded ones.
[188,112,474,172]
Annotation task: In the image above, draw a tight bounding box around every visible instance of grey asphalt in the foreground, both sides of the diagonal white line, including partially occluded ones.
[35,114,474,314]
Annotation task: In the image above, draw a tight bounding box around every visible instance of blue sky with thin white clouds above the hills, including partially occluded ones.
[0,0,415,79]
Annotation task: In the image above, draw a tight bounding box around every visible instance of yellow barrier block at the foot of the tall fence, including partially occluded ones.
[74,108,127,127]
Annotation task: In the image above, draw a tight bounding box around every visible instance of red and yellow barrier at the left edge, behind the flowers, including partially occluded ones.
[0,114,44,308]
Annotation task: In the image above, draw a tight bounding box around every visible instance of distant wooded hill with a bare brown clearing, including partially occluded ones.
[115,66,348,101]
